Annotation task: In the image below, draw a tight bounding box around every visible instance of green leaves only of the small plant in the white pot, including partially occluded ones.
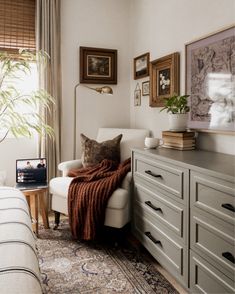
[160,94,190,114]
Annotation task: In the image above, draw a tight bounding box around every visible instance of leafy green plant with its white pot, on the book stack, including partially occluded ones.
[161,95,190,132]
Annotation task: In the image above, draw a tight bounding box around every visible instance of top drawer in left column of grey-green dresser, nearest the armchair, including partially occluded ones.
[134,155,185,199]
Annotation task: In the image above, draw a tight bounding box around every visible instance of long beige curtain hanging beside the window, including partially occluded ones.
[36,0,61,179]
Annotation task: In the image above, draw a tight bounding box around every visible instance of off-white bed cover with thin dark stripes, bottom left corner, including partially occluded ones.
[0,187,42,294]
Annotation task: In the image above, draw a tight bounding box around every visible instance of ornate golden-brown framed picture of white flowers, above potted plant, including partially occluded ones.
[149,52,180,107]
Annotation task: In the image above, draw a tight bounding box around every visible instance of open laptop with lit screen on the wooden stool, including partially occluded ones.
[16,158,47,190]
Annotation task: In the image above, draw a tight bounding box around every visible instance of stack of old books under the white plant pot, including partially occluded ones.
[162,131,196,150]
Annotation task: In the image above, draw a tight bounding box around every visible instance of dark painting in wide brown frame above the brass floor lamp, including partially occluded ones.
[80,47,117,84]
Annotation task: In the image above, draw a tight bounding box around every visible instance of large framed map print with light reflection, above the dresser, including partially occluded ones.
[185,25,235,134]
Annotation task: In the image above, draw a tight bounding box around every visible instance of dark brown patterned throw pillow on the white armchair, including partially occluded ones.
[81,134,122,167]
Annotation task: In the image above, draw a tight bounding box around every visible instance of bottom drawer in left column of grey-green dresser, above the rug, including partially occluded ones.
[134,213,187,281]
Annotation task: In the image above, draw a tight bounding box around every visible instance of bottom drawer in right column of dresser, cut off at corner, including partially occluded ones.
[190,250,235,294]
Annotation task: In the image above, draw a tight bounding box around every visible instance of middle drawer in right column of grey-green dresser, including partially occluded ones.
[191,210,235,279]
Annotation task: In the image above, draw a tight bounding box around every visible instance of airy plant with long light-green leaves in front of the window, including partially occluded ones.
[0,51,54,143]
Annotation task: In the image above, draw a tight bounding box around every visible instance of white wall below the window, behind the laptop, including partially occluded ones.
[0,138,38,186]
